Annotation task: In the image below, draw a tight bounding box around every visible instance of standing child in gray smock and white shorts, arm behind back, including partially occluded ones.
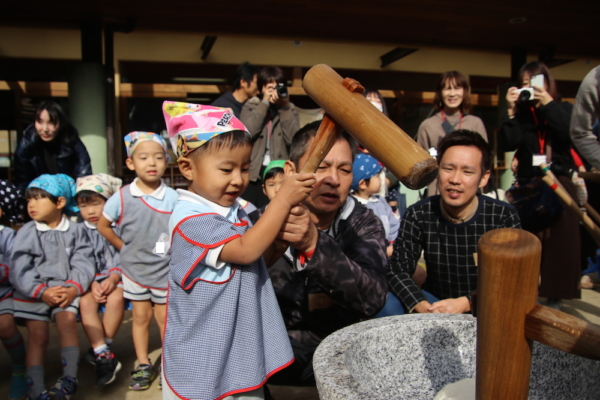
[98,132,177,390]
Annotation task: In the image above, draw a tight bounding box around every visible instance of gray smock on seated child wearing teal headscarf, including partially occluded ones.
[10,216,95,300]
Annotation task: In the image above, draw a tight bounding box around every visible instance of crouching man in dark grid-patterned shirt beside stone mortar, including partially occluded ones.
[386,129,520,315]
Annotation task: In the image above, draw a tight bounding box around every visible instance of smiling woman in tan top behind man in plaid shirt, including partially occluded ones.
[417,71,487,196]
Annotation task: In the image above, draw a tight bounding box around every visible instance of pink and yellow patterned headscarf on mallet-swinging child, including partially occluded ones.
[163,101,250,158]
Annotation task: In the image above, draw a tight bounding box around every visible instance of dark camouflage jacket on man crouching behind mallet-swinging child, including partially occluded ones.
[262,196,388,347]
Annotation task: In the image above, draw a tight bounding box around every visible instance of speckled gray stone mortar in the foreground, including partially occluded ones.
[313,314,600,400]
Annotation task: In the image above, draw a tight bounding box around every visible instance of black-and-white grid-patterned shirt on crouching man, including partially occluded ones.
[388,195,521,311]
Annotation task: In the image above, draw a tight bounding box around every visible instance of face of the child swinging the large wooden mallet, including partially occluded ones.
[190,145,252,207]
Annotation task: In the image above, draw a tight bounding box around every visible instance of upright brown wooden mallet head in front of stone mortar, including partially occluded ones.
[476,228,542,400]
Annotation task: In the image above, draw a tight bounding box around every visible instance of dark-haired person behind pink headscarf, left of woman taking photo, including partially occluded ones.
[211,62,258,118]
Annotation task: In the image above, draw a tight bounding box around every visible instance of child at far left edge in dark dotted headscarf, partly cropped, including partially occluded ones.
[0,180,28,399]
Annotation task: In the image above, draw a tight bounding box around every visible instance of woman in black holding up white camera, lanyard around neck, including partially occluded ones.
[498,61,581,308]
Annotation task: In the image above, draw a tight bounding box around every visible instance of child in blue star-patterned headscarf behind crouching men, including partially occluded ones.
[350,154,400,257]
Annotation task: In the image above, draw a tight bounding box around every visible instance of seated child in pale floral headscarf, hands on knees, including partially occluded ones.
[75,174,124,386]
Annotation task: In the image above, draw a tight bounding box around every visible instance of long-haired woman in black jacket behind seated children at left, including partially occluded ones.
[14,101,92,193]
